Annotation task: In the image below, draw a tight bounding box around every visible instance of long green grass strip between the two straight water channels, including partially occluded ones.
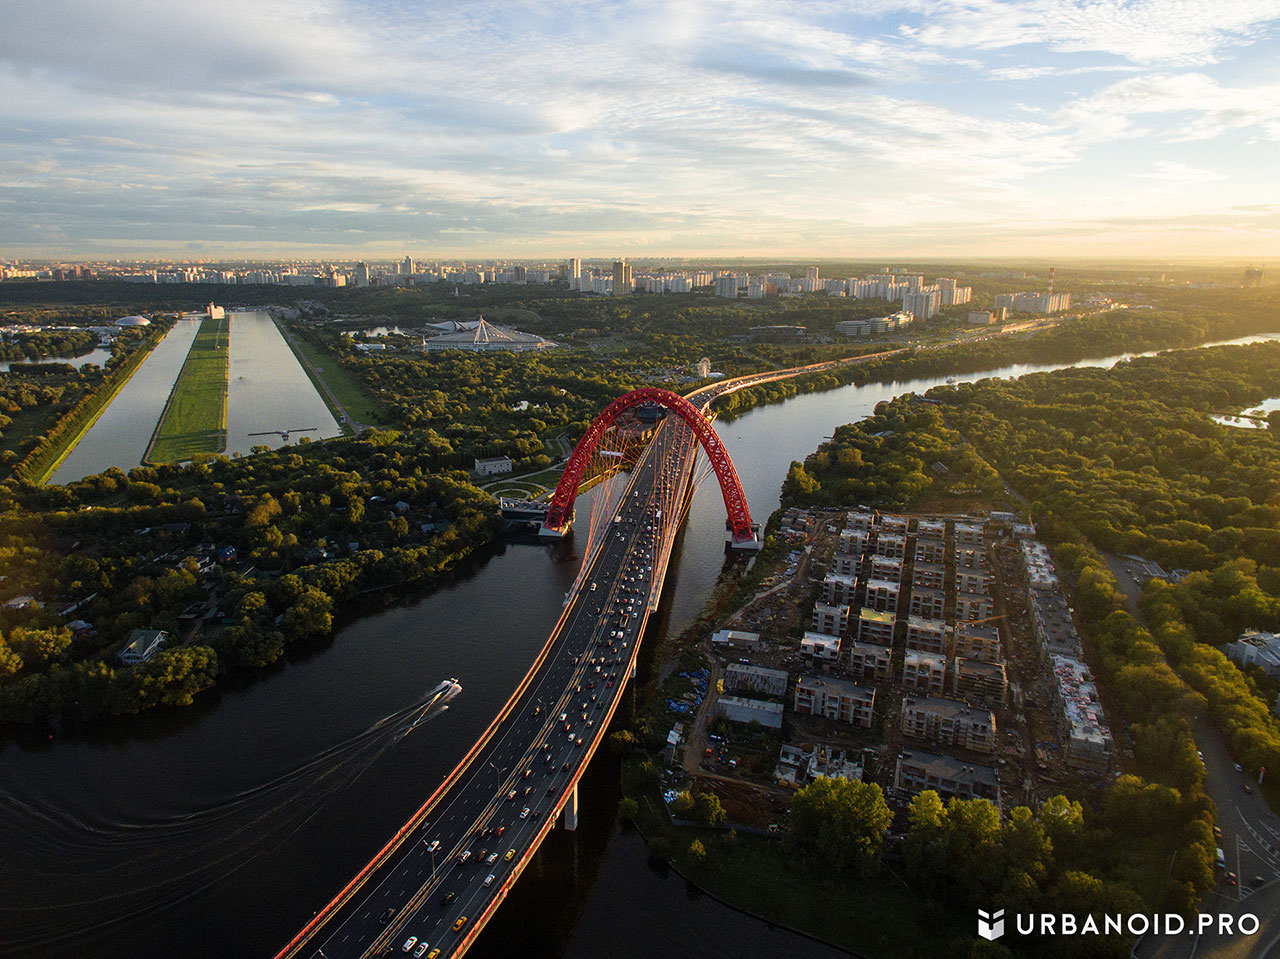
[143,319,229,462]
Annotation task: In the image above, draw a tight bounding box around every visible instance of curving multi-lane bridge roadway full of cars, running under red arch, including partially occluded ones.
[275,353,906,959]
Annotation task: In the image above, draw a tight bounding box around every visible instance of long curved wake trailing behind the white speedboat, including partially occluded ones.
[0,680,462,955]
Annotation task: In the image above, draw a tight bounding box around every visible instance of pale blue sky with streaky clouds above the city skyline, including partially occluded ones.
[0,0,1280,259]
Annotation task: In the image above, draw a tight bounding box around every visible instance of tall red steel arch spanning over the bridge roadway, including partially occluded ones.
[544,387,754,543]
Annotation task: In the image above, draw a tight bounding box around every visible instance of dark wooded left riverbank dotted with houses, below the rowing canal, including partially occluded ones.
[0,431,500,722]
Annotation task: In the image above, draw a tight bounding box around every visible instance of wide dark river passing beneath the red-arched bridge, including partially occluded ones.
[0,334,1280,959]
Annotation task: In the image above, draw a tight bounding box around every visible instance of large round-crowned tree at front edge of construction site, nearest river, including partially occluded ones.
[790,778,893,876]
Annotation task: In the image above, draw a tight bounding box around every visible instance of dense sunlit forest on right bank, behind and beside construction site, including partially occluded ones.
[768,343,1280,949]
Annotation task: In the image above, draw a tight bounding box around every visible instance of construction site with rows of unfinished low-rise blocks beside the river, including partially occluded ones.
[650,508,1115,831]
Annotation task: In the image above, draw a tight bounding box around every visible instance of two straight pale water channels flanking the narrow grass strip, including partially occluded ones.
[50,311,342,483]
